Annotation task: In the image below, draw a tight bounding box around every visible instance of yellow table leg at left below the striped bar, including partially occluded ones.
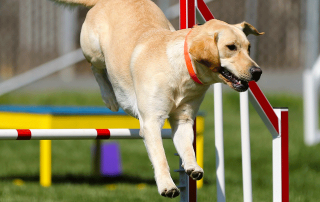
[40,140,51,187]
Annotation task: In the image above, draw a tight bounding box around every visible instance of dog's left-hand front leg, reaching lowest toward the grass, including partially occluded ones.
[140,117,180,198]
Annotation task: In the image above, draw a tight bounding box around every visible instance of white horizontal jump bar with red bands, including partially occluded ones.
[0,129,171,140]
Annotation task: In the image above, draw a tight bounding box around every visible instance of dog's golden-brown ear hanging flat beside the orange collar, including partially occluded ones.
[189,33,220,71]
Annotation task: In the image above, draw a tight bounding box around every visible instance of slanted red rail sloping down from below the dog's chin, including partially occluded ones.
[249,81,279,133]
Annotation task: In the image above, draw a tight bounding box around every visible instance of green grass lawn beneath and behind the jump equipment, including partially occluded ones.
[0,92,320,202]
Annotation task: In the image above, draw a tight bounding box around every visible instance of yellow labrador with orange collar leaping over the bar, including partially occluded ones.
[55,0,263,198]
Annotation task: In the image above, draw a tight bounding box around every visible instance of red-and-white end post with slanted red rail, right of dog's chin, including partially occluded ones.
[249,81,289,202]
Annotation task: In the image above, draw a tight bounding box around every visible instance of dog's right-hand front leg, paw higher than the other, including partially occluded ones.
[169,116,203,180]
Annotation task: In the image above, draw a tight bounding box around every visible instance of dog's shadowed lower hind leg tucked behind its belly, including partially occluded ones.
[91,66,119,112]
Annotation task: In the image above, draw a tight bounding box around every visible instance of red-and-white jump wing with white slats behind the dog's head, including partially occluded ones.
[180,0,289,202]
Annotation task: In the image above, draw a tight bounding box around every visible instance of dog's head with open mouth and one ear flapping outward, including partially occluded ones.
[189,20,264,92]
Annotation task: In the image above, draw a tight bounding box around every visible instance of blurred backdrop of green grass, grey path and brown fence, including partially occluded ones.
[0,0,320,202]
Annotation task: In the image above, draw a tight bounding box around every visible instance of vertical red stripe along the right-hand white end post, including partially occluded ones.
[281,111,289,202]
